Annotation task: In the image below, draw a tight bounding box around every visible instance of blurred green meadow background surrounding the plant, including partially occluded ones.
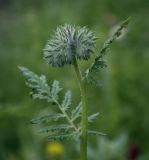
[0,0,149,160]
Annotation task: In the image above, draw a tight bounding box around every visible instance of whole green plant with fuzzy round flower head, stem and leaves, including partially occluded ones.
[19,19,129,160]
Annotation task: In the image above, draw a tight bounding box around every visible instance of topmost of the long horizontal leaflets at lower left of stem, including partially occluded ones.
[31,113,65,124]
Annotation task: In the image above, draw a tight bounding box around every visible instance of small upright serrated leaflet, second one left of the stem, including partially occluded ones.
[62,91,71,110]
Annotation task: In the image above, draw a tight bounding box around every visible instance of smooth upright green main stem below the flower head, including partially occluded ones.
[73,58,87,160]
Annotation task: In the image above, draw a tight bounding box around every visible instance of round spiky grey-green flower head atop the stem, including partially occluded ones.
[44,24,97,67]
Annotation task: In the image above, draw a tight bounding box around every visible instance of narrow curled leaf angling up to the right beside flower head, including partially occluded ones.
[85,18,130,85]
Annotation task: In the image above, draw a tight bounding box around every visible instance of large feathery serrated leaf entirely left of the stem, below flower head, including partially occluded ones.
[19,67,80,139]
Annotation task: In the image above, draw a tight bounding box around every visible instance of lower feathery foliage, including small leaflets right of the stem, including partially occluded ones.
[19,67,99,140]
